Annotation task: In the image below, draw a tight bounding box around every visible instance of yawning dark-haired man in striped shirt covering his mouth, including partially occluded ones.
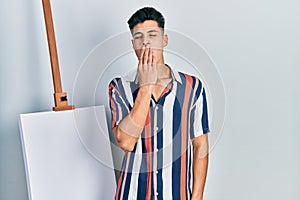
[109,7,209,200]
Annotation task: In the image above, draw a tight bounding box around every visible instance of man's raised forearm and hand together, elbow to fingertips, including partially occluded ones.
[113,46,157,151]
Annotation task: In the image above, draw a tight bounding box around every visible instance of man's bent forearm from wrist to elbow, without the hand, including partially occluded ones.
[113,86,152,151]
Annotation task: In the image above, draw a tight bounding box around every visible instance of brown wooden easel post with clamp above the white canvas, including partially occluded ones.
[42,0,74,111]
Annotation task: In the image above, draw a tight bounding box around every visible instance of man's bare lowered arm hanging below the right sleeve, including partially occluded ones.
[192,136,209,200]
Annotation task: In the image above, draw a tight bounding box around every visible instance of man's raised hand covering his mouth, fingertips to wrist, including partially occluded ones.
[138,45,157,89]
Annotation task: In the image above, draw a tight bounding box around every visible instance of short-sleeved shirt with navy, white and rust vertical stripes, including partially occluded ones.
[109,69,209,200]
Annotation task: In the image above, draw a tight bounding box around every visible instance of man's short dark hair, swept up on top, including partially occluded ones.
[127,7,165,31]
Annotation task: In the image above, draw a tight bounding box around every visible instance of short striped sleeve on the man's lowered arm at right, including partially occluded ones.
[190,84,209,139]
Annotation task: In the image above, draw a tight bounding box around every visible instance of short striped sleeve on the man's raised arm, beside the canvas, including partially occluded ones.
[108,78,130,128]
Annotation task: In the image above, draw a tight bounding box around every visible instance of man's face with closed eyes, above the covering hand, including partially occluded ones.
[132,20,168,60]
